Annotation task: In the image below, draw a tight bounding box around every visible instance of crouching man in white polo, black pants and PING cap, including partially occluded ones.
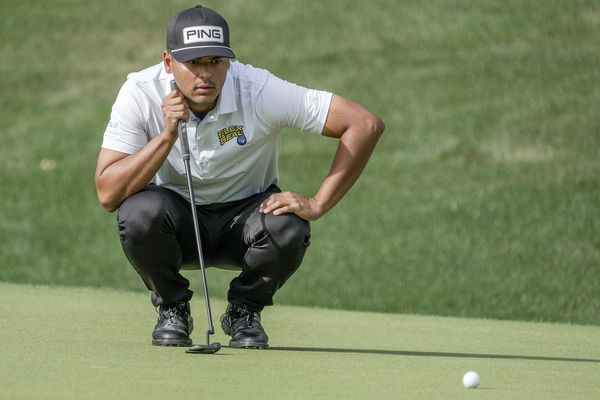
[95,6,384,348]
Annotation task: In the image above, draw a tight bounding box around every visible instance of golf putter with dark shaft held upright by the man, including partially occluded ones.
[171,79,221,354]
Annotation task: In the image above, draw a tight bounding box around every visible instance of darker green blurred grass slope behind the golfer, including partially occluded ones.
[0,0,600,325]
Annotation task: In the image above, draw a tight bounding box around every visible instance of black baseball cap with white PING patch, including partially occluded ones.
[167,6,235,62]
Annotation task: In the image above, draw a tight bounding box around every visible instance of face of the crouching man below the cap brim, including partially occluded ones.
[163,51,229,114]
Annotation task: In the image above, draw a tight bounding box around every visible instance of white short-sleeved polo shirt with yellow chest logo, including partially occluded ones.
[102,61,332,204]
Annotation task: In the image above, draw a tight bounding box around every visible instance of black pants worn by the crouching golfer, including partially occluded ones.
[117,185,310,311]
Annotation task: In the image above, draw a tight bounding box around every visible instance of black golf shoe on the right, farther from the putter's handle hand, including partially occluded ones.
[221,304,269,349]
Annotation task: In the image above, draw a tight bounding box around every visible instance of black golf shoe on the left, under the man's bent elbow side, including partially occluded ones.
[152,301,194,346]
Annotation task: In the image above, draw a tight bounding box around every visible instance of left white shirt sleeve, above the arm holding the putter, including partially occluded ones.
[102,80,148,154]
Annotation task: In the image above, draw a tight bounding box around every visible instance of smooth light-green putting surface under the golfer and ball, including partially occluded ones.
[0,283,600,400]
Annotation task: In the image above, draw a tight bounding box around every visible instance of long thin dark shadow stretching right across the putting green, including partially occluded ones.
[269,347,600,363]
